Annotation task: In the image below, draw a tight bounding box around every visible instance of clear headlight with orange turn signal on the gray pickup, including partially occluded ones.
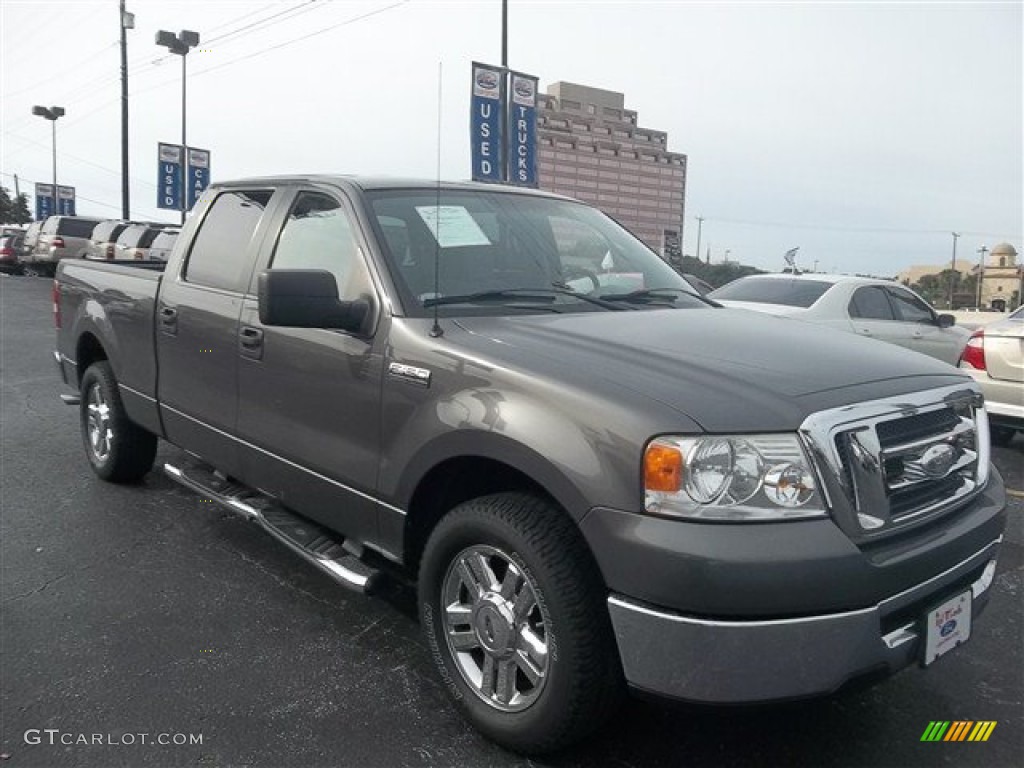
[643,434,825,521]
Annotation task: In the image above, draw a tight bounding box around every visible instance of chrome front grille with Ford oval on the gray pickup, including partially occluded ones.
[801,385,989,536]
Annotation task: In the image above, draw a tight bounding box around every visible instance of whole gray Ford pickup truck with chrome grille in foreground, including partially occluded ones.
[54,176,1006,753]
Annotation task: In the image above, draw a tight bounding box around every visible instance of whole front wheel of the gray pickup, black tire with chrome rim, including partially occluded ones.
[419,494,623,754]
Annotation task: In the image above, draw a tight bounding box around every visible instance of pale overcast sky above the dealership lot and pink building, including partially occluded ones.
[0,0,1024,275]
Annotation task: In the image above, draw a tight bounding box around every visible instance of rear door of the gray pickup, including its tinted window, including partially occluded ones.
[156,187,284,475]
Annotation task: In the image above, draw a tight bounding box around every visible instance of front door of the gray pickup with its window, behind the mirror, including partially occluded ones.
[236,187,386,542]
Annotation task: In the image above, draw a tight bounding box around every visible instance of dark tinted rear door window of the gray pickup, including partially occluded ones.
[184,189,273,293]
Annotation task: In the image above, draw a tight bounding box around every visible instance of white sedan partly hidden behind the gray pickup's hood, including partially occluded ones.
[708,273,971,366]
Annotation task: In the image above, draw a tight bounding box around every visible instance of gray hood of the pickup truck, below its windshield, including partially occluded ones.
[458,308,968,431]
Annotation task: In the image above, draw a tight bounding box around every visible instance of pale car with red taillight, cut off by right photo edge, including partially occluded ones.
[961,307,1024,445]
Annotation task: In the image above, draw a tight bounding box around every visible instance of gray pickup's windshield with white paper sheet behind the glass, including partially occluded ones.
[368,188,708,315]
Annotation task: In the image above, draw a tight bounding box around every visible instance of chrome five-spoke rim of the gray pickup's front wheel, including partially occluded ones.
[441,545,550,712]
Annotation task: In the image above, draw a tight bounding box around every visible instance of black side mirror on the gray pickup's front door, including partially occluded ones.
[259,269,370,333]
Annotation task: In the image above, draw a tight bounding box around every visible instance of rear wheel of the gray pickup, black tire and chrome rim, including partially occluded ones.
[80,360,157,482]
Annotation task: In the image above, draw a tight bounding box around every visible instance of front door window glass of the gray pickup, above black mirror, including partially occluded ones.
[270,191,370,300]
